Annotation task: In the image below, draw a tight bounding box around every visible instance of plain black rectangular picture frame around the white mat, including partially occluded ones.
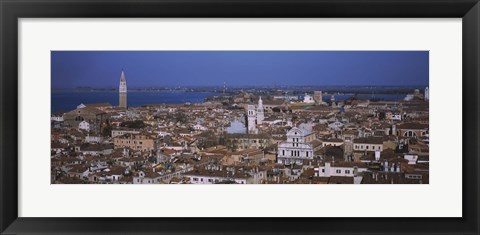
[0,0,480,234]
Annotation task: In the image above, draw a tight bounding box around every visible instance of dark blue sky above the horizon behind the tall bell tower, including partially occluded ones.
[51,51,429,88]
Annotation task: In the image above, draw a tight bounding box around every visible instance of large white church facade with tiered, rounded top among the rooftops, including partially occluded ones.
[277,127,314,164]
